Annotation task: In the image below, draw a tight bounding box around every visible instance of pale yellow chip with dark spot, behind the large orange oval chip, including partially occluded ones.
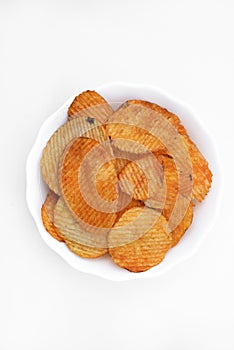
[40,117,108,195]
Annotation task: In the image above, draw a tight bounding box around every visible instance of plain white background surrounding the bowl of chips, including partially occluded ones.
[0,0,234,350]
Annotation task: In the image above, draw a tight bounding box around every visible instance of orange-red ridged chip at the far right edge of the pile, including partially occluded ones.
[183,136,212,202]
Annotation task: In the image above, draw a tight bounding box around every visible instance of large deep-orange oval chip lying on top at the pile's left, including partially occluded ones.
[59,138,118,231]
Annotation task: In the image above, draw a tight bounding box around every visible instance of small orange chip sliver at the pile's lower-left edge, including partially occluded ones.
[41,191,63,242]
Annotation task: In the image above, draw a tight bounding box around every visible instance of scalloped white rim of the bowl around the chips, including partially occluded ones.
[26,81,223,281]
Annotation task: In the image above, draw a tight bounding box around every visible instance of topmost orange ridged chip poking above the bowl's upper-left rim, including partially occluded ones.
[68,90,113,124]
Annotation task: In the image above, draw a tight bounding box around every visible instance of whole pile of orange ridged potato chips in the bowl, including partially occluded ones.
[41,91,212,272]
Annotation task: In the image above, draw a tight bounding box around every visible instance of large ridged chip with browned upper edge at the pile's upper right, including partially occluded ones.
[107,100,187,155]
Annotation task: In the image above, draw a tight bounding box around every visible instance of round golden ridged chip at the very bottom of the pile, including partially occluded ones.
[108,208,172,272]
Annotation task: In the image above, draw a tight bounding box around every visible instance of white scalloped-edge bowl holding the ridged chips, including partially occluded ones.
[26,82,221,281]
